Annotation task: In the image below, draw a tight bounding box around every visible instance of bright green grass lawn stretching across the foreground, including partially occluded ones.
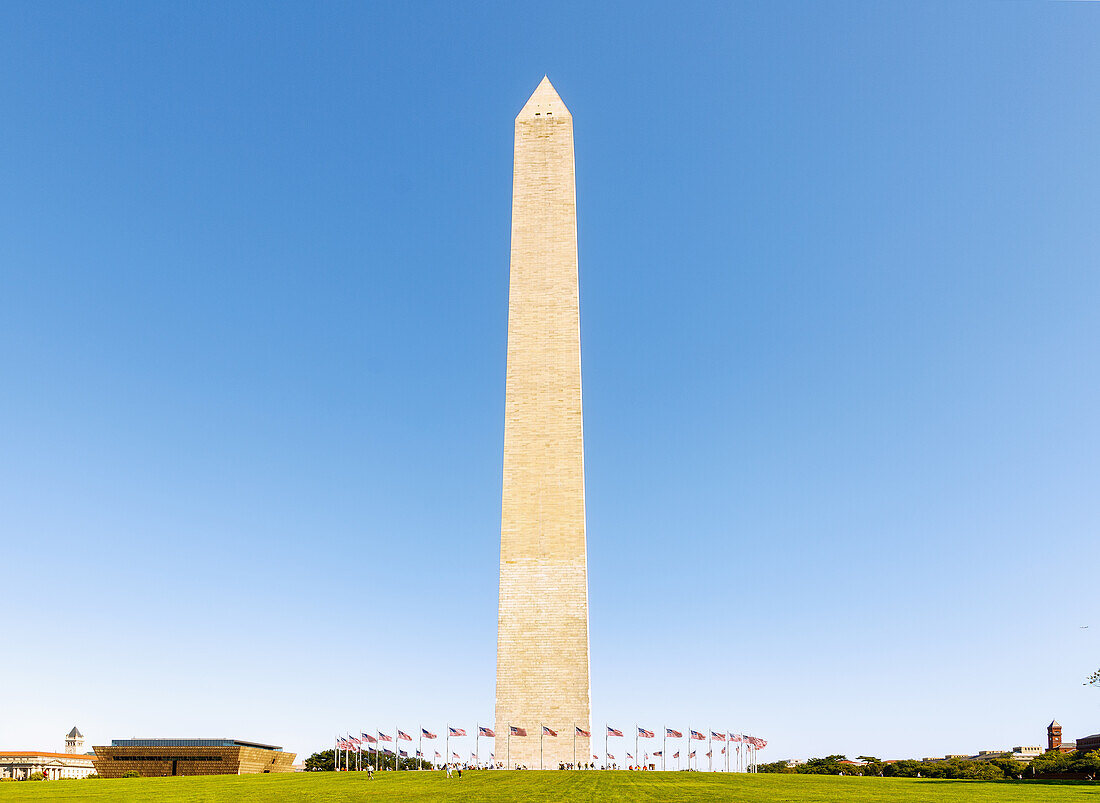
[0,771,1100,803]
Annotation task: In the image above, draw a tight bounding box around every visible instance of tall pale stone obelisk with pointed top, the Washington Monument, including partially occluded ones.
[495,78,592,769]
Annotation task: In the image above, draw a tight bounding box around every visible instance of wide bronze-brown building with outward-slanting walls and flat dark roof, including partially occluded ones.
[95,739,296,778]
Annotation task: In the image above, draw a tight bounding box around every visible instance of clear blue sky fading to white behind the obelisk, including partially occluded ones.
[0,2,1100,759]
